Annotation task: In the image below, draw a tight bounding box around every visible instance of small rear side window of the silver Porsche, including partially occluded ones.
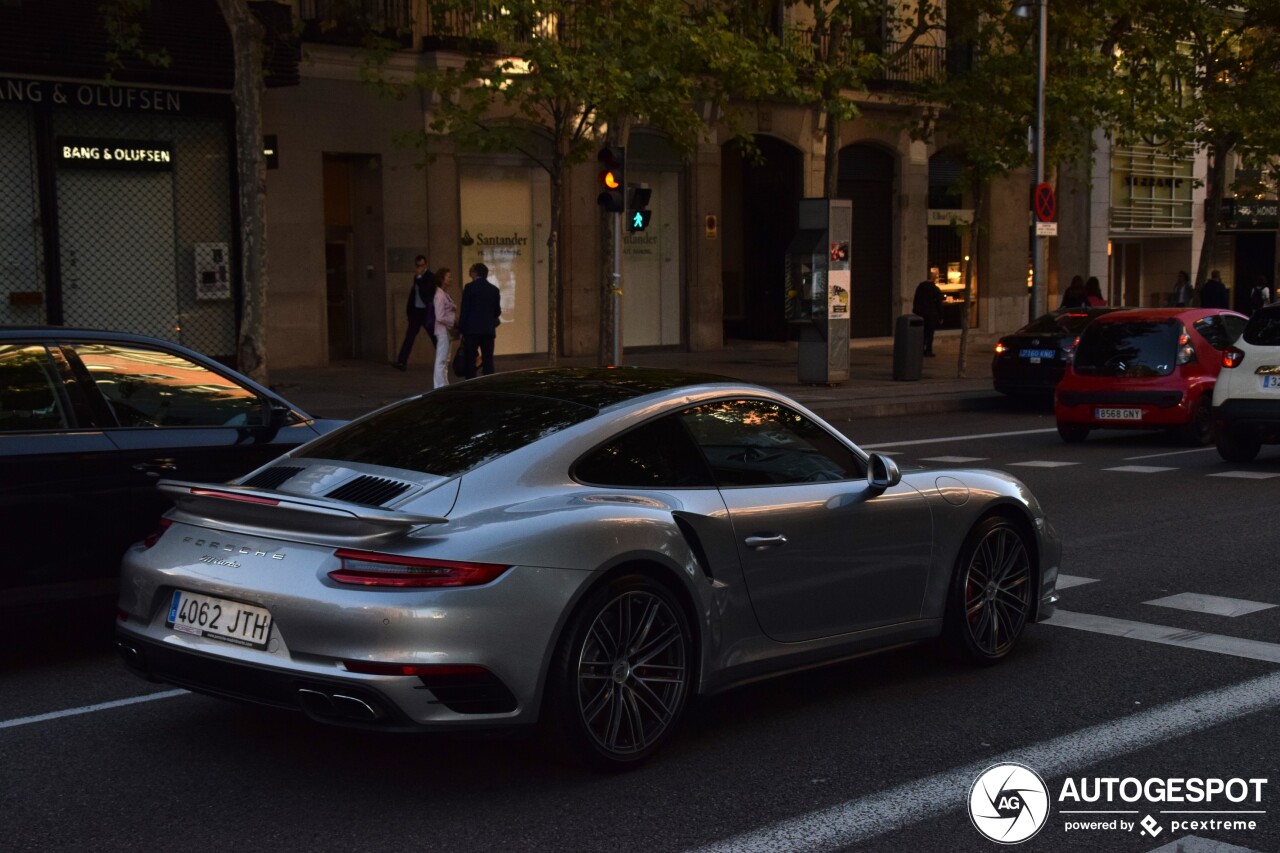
[573,416,714,488]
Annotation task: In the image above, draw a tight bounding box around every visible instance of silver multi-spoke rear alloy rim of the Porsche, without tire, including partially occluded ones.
[577,590,689,758]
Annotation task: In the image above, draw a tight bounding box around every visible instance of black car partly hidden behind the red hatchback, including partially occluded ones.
[991,306,1124,400]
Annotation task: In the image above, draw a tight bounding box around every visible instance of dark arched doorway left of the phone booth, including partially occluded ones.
[721,136,804,341]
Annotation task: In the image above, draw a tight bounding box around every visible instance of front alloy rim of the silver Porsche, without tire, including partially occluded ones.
[964,524,1032,658]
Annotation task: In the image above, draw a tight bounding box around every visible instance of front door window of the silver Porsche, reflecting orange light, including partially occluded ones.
[680,400,867,488]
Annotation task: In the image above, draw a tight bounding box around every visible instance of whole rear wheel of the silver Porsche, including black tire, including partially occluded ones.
[543,575,695,771]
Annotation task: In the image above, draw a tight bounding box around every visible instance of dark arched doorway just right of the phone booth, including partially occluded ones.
[836,142,896,338]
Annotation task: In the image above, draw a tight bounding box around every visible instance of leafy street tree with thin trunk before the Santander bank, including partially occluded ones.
[366,0,787,365]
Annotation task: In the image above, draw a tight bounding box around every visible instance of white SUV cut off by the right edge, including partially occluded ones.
[1213,302,1280,462]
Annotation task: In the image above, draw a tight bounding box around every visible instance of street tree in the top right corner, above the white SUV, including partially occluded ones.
[1111,0,1280,284]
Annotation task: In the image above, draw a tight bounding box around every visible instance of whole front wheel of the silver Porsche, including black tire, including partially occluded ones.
[943,515,1036,665]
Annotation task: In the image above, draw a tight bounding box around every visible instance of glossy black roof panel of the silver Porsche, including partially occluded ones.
[435,368,742,409]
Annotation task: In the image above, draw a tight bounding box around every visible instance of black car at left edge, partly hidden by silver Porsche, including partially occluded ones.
[0,327,340,607]
